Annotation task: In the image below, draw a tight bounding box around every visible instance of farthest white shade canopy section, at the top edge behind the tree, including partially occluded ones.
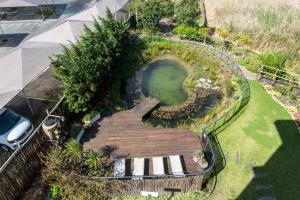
[69,0,128,22]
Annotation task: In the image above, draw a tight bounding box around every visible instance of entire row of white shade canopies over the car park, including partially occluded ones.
[0,0,129,109]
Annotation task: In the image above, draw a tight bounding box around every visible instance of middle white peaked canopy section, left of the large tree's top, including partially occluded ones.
[28,20,92,44]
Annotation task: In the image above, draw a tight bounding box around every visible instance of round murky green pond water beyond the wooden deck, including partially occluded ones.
[142,59,187,106]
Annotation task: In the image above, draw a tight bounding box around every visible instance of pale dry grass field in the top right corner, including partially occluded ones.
[205,0,300,73]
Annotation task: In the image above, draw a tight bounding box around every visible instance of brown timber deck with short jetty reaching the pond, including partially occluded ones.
[81,98,202,173]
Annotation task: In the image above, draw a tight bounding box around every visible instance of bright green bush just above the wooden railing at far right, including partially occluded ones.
[259,52,287,69]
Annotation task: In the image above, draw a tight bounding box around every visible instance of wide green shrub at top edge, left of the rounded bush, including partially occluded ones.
[130,0,174,30]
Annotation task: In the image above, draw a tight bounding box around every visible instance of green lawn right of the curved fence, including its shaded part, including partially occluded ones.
[115,81,300,200]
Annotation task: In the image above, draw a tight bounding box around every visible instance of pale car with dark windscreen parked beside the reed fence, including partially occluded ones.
[0,108,34,151]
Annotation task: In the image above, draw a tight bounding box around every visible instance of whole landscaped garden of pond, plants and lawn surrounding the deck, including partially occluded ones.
[18,0,300,199]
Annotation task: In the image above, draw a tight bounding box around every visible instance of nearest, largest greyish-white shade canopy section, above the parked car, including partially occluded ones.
[0,43,62,108]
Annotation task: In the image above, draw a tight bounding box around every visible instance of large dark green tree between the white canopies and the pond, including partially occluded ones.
[51,10,141,113]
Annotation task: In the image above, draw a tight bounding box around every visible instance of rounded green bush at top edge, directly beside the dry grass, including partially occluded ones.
[174,0,201,26]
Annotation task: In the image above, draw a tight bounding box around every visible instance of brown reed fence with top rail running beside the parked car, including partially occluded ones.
[0,99,63,200]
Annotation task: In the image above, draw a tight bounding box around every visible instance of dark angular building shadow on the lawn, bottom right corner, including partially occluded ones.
[237,120,300,200]
